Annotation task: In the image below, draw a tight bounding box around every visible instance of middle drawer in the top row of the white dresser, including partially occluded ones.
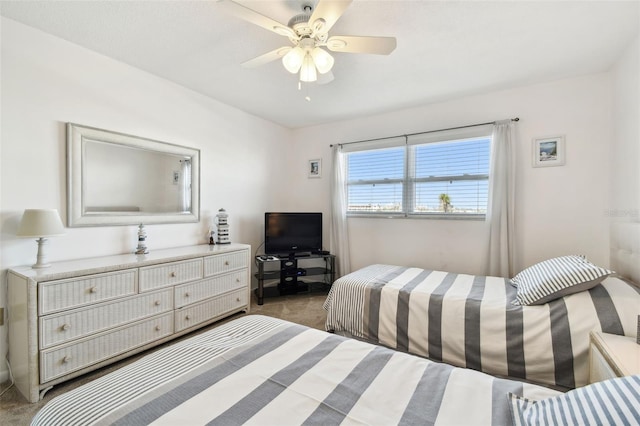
[140,259,202,292]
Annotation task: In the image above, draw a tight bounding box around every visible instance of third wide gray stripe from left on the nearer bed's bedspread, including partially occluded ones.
[303,346,393,425]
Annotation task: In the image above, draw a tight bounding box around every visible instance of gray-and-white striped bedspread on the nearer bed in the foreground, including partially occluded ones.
[32,315,558,426]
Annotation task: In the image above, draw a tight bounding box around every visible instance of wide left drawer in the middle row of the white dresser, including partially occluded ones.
[40,289,173,349]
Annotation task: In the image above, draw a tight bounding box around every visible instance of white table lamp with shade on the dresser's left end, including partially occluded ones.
[17,209,64,268]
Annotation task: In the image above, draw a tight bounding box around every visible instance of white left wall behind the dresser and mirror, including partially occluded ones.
[0,18,291,381]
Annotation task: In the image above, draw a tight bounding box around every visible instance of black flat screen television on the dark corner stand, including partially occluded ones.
[264,212,322,256]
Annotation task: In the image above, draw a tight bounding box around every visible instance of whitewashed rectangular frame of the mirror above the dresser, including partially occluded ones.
[67,123,200,227]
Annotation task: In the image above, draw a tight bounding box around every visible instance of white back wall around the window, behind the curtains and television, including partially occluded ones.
[291,73,612,274]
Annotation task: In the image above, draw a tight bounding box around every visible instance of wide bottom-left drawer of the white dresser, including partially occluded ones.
[40,312,173,383]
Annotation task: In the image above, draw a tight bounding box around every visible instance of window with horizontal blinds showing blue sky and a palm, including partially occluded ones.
[343,127,491,218]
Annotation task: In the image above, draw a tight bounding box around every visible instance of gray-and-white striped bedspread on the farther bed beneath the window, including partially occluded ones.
[324,265,640,389]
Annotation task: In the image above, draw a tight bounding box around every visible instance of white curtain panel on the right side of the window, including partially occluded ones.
[487,120,516,278]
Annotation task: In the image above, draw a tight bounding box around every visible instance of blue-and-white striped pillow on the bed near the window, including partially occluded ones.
[511,255,613,305]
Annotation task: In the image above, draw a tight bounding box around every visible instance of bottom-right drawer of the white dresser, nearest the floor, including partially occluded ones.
[175,288,248,333]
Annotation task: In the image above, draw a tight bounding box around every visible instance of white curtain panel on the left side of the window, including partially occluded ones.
[331,145,351,277]
